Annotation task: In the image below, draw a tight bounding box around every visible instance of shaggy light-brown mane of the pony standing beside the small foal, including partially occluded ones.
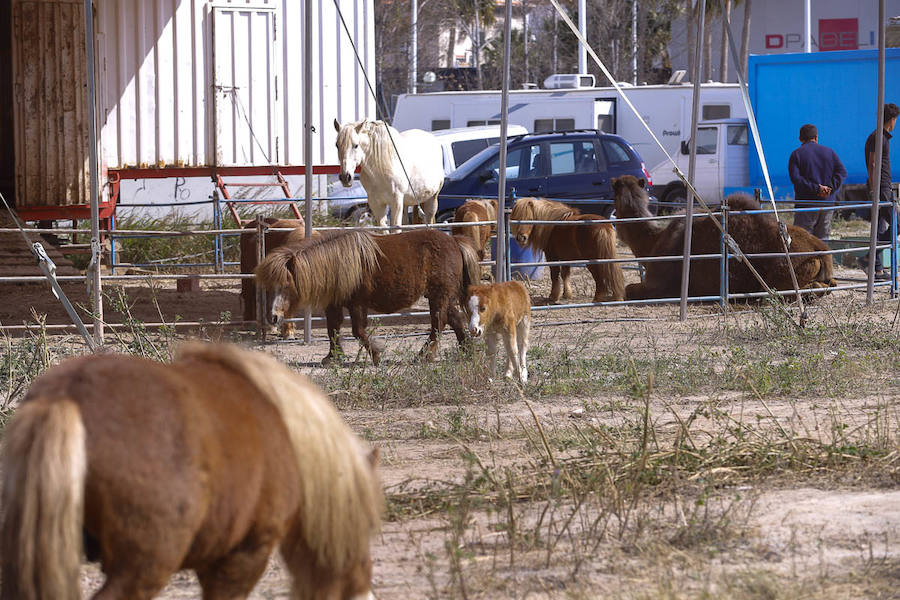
[255,231,382,308]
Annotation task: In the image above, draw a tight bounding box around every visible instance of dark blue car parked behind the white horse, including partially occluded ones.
[437,129,656,221]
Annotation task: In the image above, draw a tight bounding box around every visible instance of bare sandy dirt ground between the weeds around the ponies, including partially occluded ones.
[7,223,900,599]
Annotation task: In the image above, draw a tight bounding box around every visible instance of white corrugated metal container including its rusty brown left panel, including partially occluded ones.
[13,0,376,206]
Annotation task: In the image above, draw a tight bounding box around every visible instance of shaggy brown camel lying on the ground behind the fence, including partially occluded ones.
[612,175,836,300]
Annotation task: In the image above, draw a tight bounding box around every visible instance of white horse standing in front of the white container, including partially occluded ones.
[334,119,444,231]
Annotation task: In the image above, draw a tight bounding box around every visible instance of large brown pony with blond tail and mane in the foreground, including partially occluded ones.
[0,343,382,600]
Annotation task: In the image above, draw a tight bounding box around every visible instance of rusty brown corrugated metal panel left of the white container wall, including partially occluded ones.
[12,0,90,207]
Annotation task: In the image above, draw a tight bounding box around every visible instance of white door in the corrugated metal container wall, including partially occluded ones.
[213,7,281,166]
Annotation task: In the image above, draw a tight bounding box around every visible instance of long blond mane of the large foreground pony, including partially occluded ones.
[176,342,384,572]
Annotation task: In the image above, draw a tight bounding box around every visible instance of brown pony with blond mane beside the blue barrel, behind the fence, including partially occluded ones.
[510,198,625,302]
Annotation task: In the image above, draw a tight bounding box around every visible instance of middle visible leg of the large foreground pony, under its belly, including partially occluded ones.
[197,532,278,600]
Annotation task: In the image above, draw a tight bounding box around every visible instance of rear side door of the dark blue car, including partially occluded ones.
[547,138,612,212]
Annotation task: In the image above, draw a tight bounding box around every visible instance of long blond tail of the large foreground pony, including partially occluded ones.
[0,399,87,600]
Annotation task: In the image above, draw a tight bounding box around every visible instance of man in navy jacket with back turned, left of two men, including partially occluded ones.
[788,124,847,239]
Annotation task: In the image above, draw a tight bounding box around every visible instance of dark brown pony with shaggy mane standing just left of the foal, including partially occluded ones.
[256,229,480,365]
